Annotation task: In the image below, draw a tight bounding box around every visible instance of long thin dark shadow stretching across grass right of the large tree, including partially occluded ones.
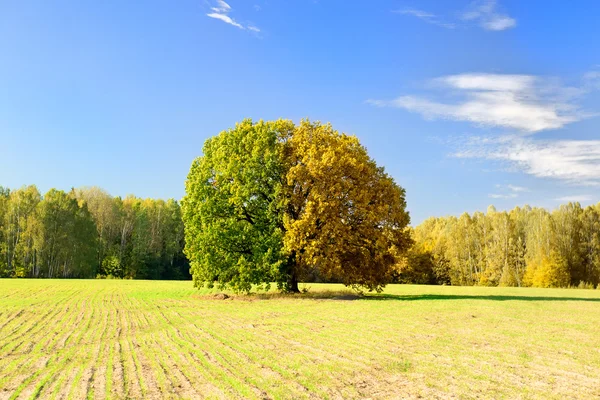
[363,293,600,303]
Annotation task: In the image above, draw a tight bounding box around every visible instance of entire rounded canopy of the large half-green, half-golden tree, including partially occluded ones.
[182,120,410,292]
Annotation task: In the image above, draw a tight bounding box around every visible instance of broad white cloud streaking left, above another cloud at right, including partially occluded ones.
[367,73,590,133]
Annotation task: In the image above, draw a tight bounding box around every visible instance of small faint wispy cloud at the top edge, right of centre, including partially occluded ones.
[393,0,517,31]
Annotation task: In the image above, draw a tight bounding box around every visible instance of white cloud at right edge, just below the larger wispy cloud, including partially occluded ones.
[453,136,600,186]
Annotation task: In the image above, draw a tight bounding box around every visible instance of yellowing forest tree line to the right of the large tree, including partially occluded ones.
[396,203,600,288]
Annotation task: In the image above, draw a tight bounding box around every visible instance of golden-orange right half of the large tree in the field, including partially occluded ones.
[284,120,411,291]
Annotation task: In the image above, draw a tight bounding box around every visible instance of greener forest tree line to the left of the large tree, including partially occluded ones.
[0,185,189,279]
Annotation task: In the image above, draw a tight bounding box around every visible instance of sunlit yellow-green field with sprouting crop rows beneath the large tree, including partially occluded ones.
[0,280,600,399]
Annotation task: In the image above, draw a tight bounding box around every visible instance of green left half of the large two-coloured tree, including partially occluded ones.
[182,120,294,291]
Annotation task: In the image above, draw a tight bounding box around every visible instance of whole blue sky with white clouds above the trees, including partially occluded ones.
[0,0,600,223]
